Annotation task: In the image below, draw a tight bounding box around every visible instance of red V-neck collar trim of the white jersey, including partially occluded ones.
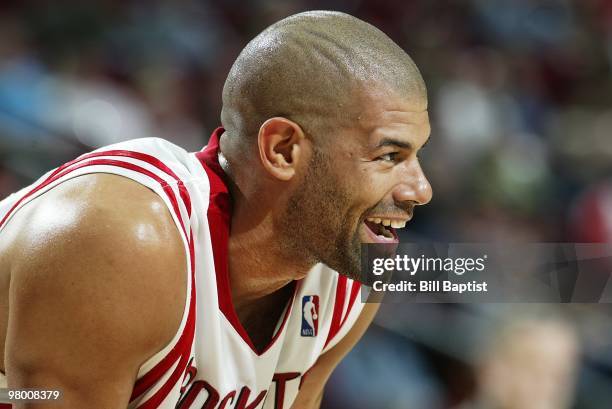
[196,128,298,356]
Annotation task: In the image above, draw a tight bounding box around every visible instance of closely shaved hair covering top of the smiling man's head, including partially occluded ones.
[221,11,426,143]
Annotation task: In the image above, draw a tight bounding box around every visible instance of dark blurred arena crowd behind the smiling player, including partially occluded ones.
[0,0,612,409]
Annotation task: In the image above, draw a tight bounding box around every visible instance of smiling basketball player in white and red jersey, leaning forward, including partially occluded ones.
[0,11,431,409]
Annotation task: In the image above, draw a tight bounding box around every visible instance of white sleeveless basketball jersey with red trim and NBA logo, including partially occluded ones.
[0,128,364,409]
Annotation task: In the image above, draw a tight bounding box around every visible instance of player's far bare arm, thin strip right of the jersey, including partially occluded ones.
[291,303,380,409]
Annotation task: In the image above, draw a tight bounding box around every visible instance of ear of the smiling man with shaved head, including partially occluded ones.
[257,117,306,181]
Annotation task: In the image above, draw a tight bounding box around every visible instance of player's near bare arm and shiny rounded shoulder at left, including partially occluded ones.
[5,175,186,409]
